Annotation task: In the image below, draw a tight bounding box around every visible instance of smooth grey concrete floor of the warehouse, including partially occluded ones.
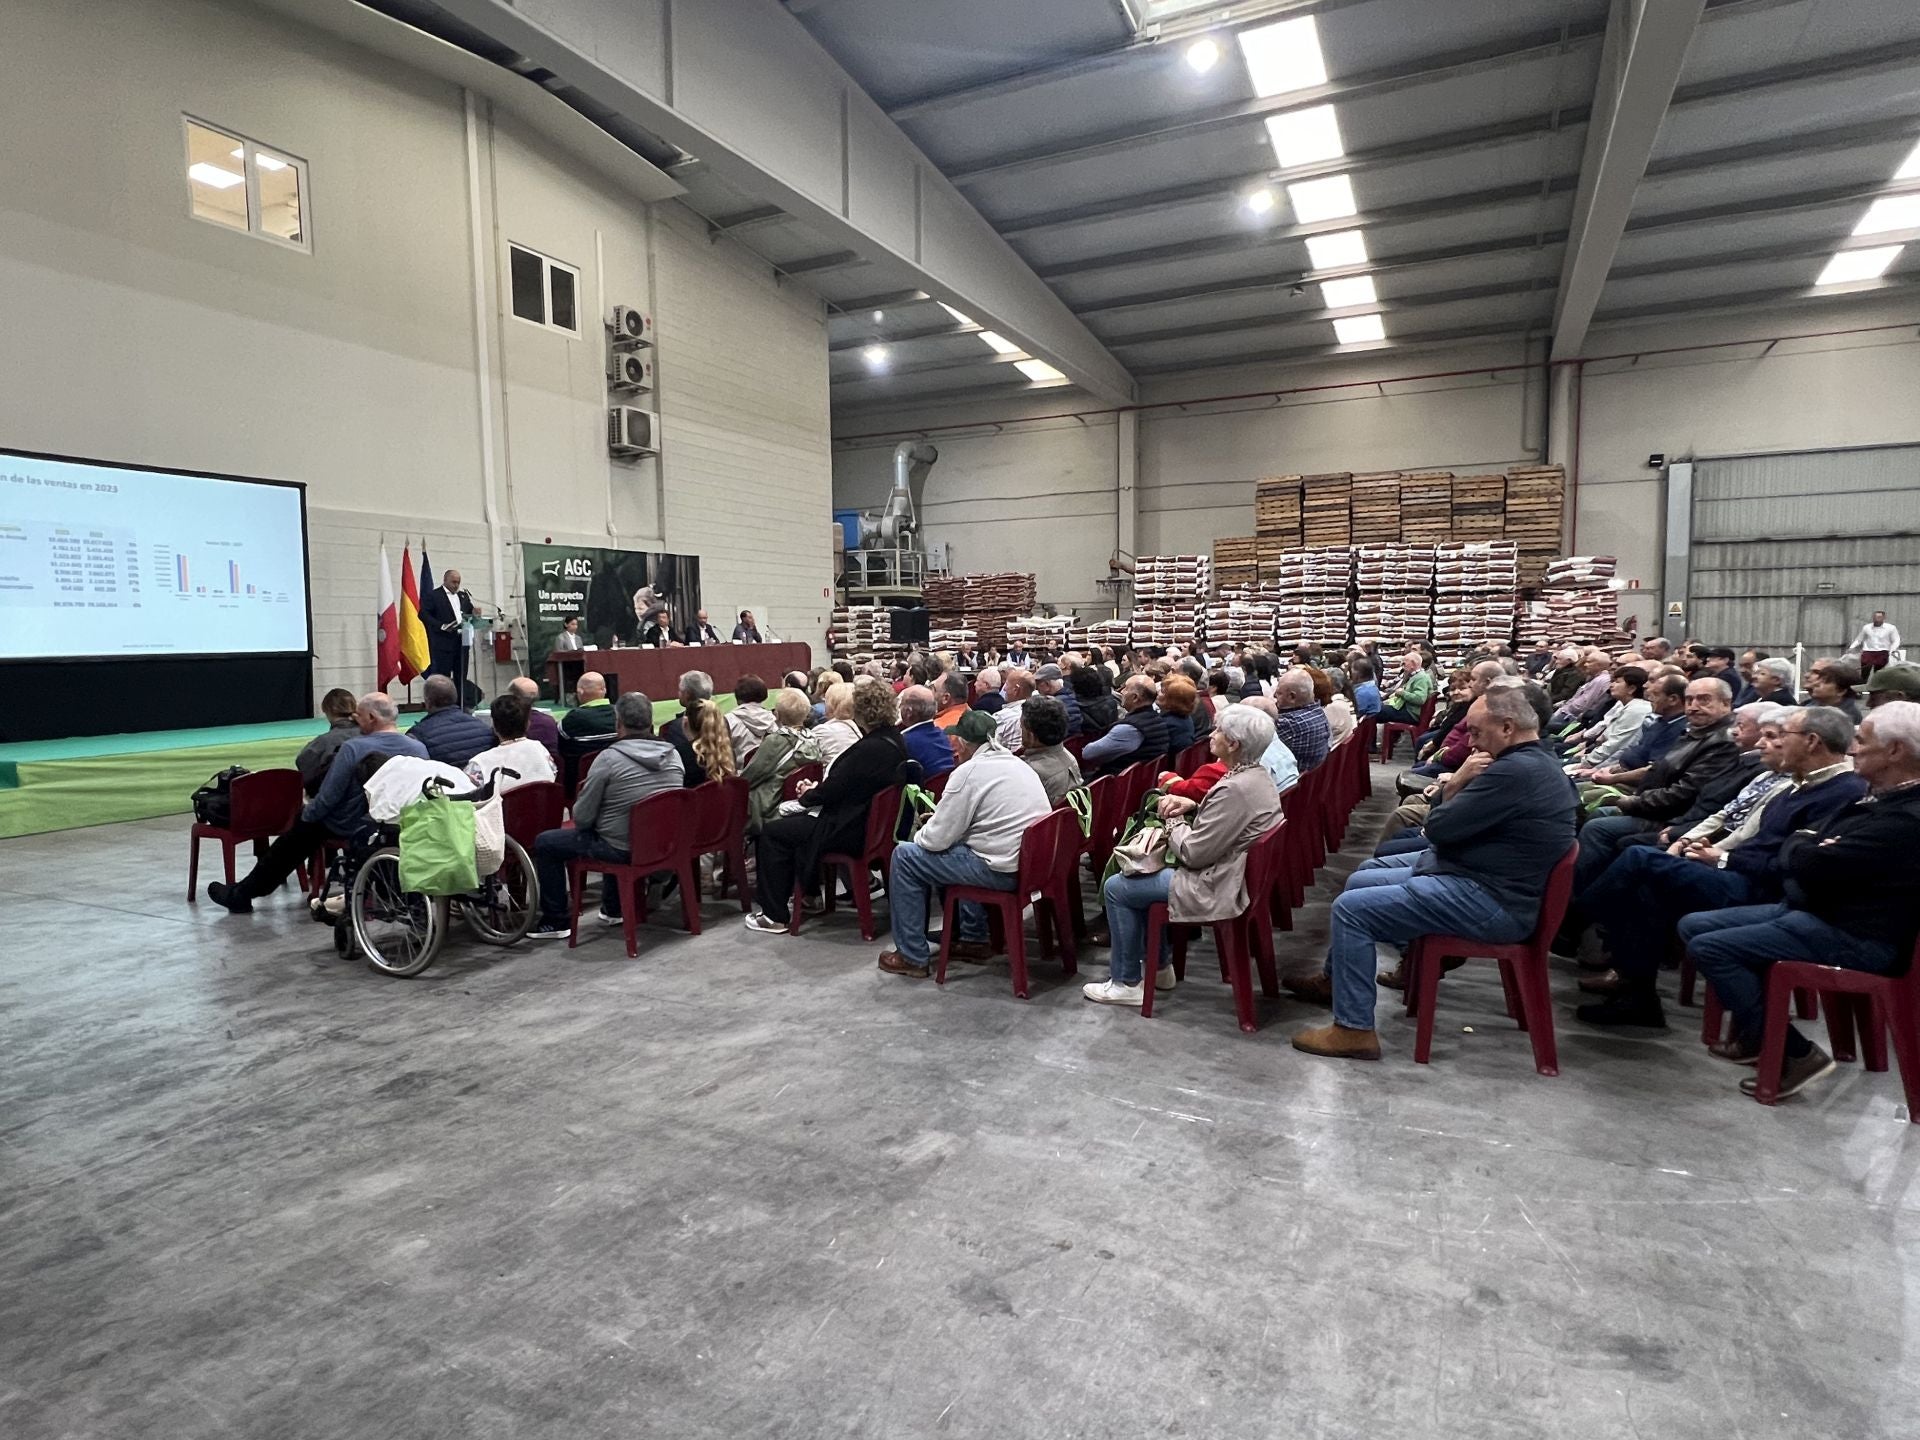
[0,778,1920,1440]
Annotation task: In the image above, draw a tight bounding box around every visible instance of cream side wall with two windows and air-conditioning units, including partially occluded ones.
[0,0,831,706]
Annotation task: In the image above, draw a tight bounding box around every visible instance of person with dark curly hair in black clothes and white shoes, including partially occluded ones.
[747,684,906,935]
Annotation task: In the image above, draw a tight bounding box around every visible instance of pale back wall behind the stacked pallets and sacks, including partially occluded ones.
[833,296,1920,634]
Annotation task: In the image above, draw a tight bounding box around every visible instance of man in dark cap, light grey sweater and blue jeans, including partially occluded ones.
[879,710,1052,979]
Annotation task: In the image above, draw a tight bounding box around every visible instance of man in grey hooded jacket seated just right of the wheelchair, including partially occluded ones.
[528,689,685,941]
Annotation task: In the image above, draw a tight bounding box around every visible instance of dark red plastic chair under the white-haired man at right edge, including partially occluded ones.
[1743,945,1920,1125]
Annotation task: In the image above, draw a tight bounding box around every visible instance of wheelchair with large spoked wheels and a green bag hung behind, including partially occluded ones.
[311,756,540,979]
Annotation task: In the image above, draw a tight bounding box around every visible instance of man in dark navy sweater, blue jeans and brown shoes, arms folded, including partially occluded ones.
[1292,680,1574,1060]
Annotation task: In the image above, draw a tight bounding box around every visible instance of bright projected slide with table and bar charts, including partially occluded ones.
[0,451,309,660]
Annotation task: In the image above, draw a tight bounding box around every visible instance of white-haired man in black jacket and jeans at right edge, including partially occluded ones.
[1678,701,1920,1094]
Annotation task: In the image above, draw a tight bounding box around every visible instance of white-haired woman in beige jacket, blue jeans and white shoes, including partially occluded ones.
[1083,705,1281,1004]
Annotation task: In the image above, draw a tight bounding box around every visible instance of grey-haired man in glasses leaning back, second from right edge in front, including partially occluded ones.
[1578,708,1866,1027]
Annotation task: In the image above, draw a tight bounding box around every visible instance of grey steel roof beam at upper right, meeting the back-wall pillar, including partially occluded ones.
[1553,0,1705,359]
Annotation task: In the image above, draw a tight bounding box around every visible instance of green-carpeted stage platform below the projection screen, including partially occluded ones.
[0,695,706,839]
